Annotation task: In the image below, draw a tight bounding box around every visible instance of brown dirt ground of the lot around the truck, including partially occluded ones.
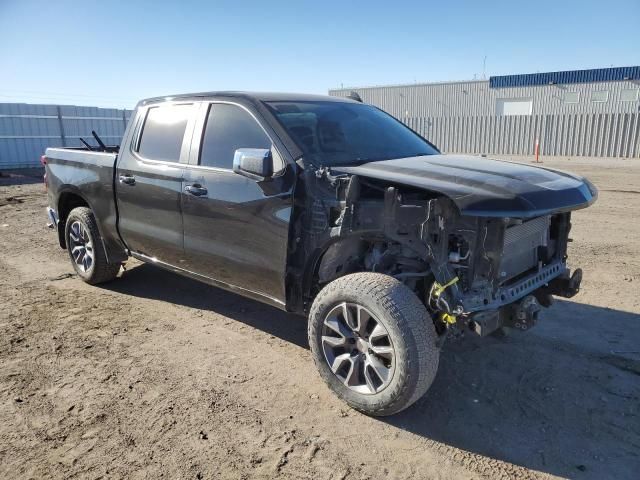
[0,159,640,480]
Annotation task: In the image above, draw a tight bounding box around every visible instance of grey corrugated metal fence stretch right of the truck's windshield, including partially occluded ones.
[401,113,640,158]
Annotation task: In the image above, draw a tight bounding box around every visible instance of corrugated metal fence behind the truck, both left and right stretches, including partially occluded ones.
[0,103,640,170]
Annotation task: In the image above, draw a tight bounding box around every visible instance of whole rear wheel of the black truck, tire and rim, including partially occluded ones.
[65,207,120,285]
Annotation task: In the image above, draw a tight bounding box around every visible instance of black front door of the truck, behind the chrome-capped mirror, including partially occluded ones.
[182,102,293,305]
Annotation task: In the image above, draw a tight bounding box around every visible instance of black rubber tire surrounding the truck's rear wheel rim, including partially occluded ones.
[64,207,120,285]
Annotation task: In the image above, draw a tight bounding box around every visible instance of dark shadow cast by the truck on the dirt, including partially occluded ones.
[106,265,640,480]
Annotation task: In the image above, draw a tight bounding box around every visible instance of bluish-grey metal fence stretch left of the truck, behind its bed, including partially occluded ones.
[0,103,131,170]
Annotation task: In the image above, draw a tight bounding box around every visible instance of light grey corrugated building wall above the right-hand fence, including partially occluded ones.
[329,80,640,118]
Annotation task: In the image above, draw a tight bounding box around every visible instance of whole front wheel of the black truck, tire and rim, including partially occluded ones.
[309,272,440,416]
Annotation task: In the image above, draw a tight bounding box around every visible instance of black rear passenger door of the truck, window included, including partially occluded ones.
[116,103,196,266]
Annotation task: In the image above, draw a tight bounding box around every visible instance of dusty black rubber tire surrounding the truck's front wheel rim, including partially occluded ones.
[308,272,440,416]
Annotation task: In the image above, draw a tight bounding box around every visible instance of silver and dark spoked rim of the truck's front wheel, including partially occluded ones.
[321,302,395,395]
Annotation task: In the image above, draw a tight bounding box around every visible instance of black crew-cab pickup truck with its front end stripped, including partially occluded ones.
[43,92,597,415]
